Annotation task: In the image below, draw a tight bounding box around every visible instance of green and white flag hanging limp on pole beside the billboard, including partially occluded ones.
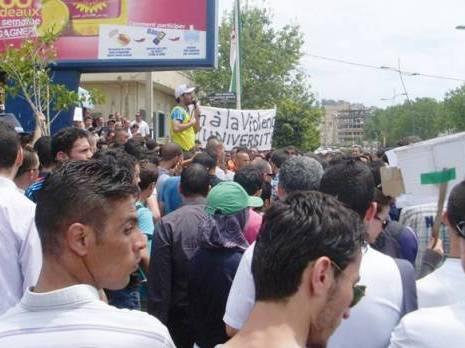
[229,0,241,109]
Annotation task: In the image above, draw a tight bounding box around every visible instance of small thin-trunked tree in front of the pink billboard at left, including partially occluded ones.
[0,28,103,135]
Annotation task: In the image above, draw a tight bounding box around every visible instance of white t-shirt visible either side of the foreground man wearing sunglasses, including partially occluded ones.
[223,243,403,348]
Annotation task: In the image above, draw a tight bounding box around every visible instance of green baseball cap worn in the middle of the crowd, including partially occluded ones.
[206,181,263,215]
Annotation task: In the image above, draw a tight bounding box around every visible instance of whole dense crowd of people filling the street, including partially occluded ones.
[0,86,465,348]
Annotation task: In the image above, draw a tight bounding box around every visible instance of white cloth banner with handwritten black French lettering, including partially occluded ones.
[198,106,276,151]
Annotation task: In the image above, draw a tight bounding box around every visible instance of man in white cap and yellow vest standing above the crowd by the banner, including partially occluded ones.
[170,85,200,151]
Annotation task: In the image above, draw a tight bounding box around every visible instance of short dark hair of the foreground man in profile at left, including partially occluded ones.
[35,159,139,255]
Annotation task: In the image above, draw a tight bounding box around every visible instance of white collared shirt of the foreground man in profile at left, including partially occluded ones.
[0,284,174,348]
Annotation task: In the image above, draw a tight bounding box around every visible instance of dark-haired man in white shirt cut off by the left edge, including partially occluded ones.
[0,122,42,314]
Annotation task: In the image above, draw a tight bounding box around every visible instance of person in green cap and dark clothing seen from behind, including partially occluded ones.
[189,181,263,348]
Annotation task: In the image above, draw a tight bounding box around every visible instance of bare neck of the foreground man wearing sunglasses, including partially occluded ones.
[227,302,310,348]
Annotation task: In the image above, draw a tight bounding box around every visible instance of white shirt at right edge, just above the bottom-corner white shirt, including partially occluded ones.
[417,258,465,308]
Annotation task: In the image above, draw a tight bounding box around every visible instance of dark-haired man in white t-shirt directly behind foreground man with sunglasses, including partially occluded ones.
[223,160,416,348]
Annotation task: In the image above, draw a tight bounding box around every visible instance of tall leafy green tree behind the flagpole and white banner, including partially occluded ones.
[192,7,321,150]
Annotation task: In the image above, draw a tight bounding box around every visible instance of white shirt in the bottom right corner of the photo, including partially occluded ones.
[389,302,465,348]
